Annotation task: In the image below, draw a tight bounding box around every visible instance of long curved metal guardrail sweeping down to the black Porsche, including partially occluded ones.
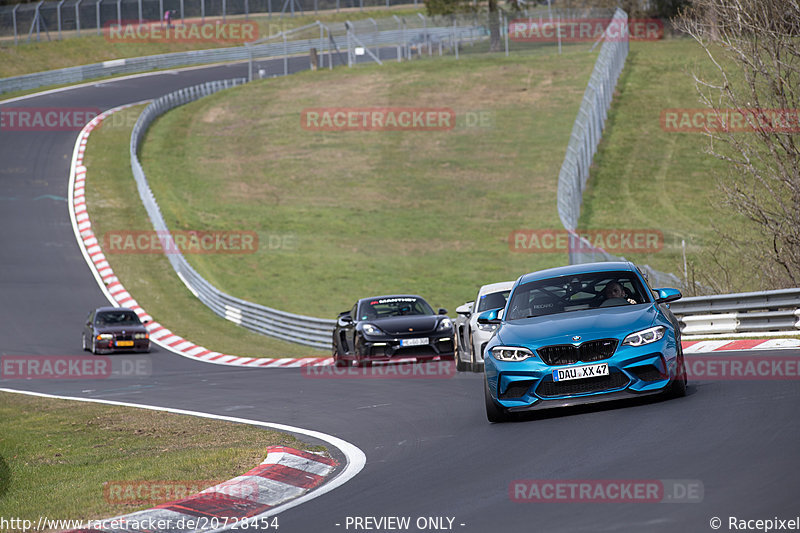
[130,78,335,349]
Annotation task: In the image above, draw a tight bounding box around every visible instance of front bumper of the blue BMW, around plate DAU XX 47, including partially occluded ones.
[485,331,678,412]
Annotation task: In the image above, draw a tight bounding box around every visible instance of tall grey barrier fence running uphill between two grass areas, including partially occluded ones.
[558,9,683,287]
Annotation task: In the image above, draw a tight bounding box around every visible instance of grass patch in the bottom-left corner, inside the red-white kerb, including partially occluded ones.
[0,393,322,523]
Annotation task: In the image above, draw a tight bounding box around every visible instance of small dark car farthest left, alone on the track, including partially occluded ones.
[82,307,150,354]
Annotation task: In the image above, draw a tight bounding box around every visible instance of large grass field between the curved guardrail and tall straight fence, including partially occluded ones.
[142,47,596,316]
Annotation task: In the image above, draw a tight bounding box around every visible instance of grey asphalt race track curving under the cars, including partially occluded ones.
[0,58,800,533]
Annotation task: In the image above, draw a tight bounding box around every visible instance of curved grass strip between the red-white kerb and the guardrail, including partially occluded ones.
[85,106,325,357]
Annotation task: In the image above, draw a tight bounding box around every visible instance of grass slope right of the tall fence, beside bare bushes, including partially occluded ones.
[580,38,766,292]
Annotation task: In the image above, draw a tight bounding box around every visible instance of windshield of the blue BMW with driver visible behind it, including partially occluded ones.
[506,271,650,320]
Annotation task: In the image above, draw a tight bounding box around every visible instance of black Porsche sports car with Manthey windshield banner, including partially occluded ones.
[333,294,455,366]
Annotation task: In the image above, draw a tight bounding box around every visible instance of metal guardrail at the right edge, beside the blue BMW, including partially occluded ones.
[670,289,800,335]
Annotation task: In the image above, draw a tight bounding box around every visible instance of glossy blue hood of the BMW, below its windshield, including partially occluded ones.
[496,304,658,348]
